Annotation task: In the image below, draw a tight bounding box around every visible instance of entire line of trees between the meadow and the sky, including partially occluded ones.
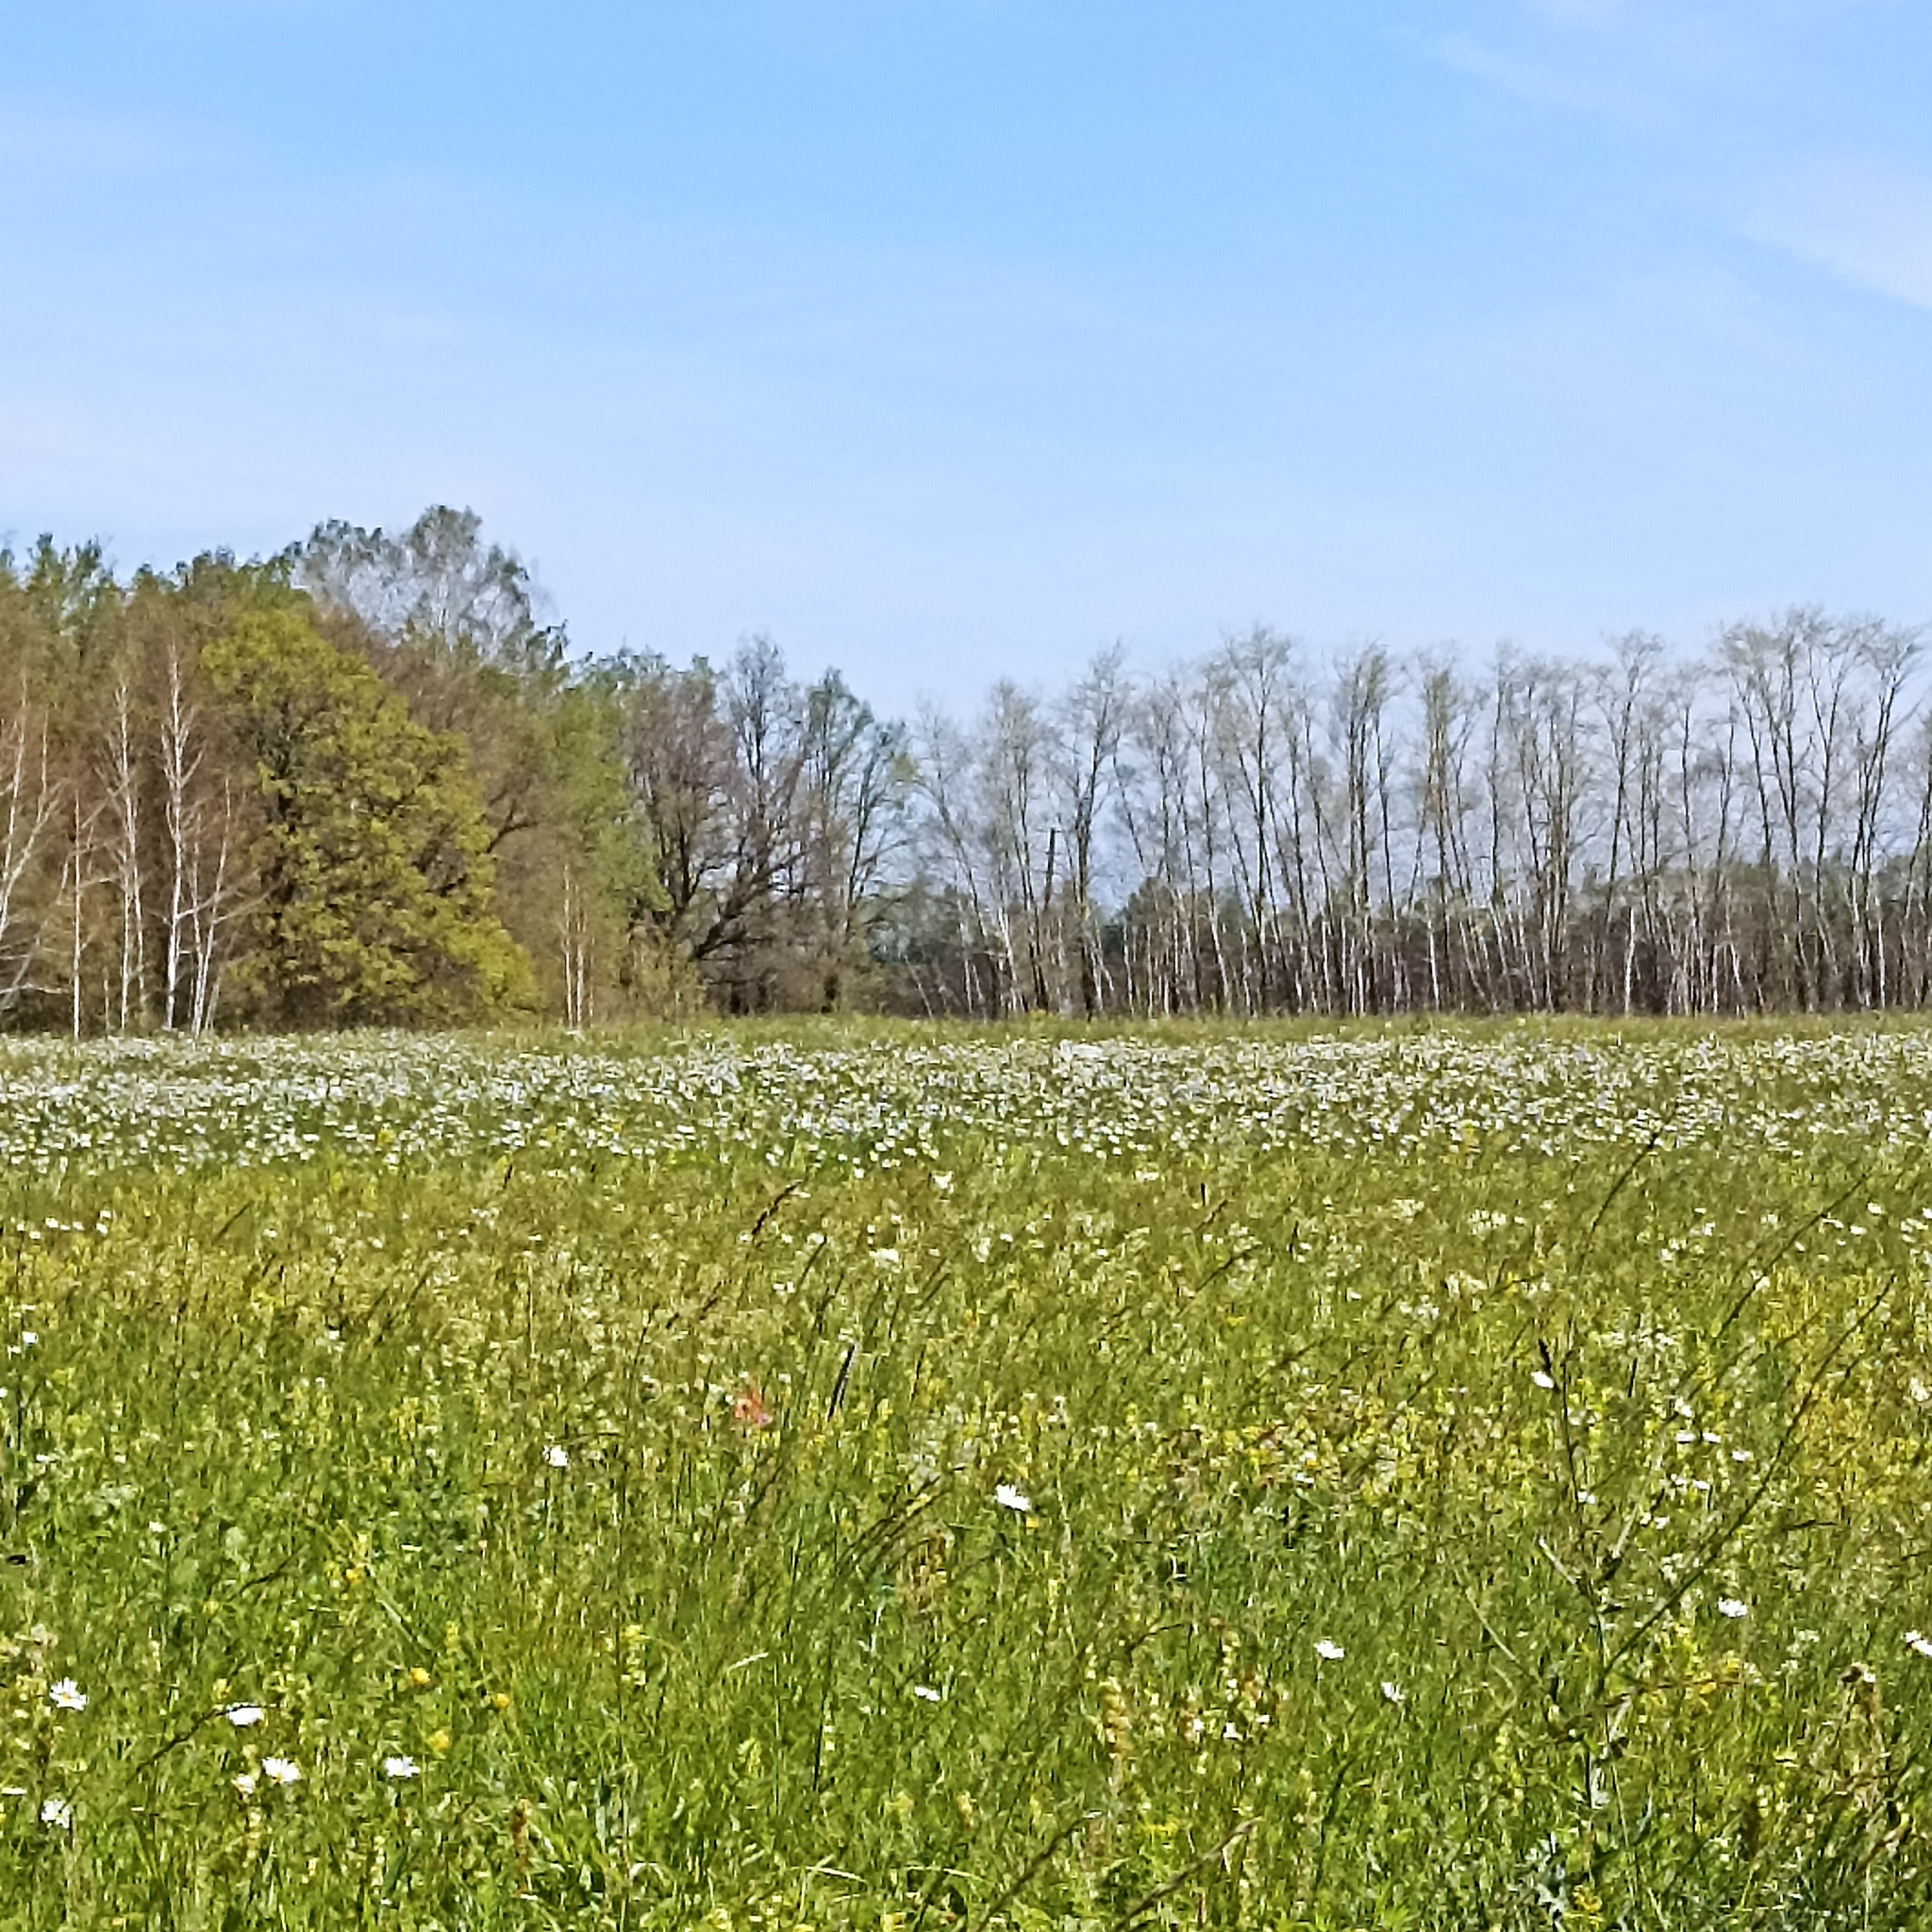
[0,510,1932,1036]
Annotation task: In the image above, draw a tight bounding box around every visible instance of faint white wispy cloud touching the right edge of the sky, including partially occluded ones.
[1748,158,1932,309]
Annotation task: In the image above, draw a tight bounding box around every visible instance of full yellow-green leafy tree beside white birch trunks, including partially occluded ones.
[201,610,529,1025]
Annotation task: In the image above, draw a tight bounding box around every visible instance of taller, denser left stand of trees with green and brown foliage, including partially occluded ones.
[0,510,910,1036]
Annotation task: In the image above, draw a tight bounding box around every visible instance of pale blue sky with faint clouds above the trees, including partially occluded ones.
[0,0,1932,709]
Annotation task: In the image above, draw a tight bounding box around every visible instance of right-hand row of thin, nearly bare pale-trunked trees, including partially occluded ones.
[910,610,1932,1014]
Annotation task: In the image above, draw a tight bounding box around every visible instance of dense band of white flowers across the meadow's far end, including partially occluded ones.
[0,1034,1932,1174]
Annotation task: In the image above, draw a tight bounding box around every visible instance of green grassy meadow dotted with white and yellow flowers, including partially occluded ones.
[0,1028,1932,1932]
